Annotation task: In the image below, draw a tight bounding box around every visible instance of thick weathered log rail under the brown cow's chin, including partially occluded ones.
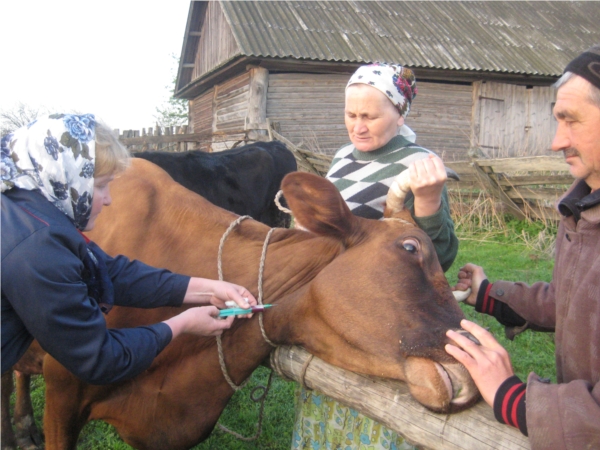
[270,346,530,450]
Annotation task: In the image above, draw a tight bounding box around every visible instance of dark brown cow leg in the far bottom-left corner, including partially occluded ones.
[13,370,44,450]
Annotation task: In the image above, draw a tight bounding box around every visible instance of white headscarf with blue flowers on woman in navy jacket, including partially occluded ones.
[1,114,96,231]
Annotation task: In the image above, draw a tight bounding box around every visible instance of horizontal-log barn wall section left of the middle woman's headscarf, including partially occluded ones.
[267,73,350,155]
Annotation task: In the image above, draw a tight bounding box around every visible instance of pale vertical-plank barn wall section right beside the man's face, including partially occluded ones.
[473,82,556,158]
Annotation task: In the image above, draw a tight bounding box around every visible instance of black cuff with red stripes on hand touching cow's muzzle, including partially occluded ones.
[494,375,527,436]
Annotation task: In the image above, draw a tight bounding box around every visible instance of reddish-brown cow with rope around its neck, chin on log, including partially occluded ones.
[44,160,479,450]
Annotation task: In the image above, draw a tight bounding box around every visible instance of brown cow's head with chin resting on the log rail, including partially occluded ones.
[282,172,479,412]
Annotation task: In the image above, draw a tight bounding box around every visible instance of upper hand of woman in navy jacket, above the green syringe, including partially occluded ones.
[183,278,258,318]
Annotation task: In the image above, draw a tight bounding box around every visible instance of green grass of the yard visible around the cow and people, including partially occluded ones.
[14,215,556,450]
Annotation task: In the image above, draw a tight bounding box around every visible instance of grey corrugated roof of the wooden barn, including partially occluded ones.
[220,1,600,76]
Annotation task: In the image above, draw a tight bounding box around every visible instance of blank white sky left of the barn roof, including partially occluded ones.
[0,0,190,130]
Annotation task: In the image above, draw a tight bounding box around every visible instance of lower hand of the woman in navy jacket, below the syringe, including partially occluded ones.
[164,306,234,339]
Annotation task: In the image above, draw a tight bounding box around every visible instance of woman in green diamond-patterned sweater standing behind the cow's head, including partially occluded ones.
[292,64,458,450]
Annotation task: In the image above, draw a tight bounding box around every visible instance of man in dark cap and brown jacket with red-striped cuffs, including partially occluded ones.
[446,45,600,450]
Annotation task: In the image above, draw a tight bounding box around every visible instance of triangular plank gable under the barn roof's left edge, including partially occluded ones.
[192,2,239,81]
